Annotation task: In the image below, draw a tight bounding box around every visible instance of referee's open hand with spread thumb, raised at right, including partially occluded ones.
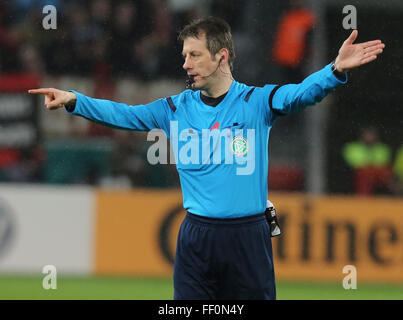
[334,30,385,72]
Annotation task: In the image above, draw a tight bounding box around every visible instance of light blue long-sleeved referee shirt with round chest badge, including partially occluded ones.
[69,64,347,218]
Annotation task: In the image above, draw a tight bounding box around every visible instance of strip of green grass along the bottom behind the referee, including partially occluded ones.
[0,276,403,300]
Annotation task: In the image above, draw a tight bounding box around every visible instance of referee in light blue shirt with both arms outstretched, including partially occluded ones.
[29,17,385,299]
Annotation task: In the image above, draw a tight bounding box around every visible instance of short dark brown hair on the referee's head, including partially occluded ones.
[178,17,235,71]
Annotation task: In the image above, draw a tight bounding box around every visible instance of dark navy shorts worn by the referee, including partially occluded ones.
[174,213,276,300]
